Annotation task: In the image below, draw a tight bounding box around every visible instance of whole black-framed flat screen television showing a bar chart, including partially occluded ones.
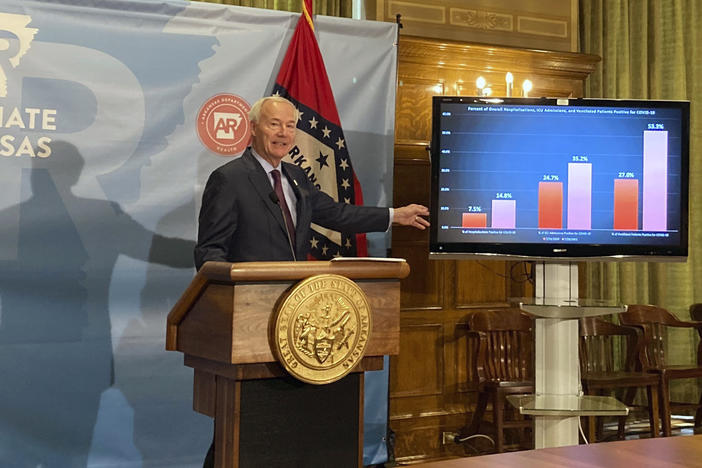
[430,96,690,261]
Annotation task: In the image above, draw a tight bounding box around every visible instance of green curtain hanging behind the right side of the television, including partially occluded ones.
[580,0,702,401]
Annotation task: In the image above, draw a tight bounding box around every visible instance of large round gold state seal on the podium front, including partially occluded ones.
[273,274,371,385]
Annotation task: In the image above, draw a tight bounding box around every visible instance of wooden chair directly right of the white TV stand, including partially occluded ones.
[580,317,663,442]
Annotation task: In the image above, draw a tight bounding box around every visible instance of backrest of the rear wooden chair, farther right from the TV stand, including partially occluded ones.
[619,304,679,369]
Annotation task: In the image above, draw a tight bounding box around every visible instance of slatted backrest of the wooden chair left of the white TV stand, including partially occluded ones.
[467,308,534,382]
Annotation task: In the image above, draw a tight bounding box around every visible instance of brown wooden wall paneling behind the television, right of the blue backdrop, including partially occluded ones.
[390,36,599,463]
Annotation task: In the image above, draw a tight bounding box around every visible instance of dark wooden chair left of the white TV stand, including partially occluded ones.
[461,308,534,453]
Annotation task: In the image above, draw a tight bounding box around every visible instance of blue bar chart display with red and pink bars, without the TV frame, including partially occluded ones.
[439,105,681,249]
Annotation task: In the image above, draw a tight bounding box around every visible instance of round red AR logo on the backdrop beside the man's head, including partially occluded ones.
[197,94,251,156]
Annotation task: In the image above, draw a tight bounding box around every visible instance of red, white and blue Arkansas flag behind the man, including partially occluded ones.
[273,0,368,260]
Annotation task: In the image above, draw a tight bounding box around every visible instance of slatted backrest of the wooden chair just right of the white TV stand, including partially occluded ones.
[580,317,645,375]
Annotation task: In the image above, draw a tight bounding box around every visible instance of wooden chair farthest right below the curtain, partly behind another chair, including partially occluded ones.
[619,304,702,436]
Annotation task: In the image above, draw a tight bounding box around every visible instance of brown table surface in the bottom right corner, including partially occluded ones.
[414,435,702,468]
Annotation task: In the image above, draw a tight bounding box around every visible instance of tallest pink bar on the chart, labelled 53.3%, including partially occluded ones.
[642,130,668,231]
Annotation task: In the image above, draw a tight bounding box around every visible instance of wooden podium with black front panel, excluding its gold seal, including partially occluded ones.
[166,259,409,468]
